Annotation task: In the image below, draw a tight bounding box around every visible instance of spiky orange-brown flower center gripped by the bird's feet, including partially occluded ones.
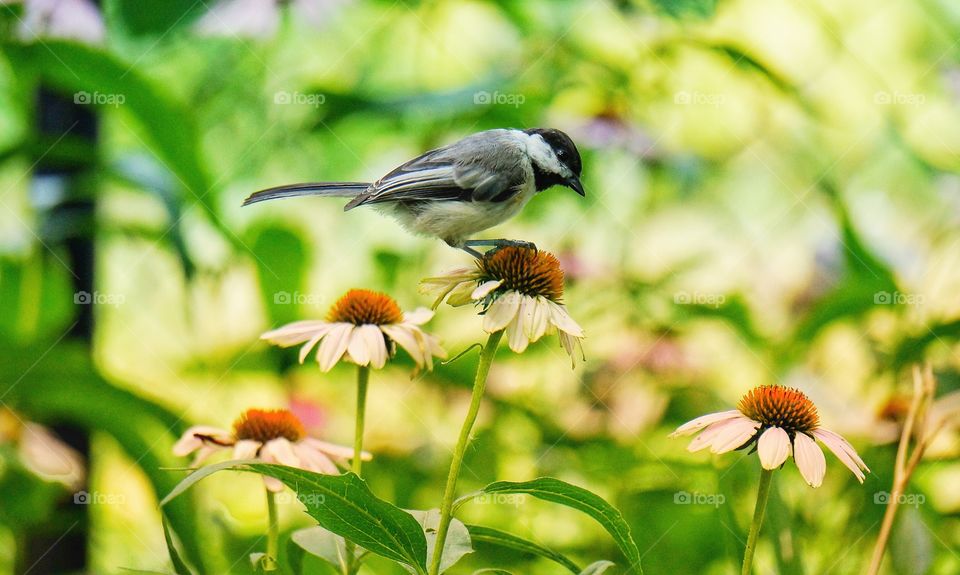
[477,246,563,303]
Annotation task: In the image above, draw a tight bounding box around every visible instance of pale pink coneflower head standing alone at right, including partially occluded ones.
[670,385,870,487]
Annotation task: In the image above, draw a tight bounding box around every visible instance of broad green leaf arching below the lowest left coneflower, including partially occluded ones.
[161,461,427,574]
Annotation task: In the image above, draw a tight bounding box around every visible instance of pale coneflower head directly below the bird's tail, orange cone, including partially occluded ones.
[260,289,447,371]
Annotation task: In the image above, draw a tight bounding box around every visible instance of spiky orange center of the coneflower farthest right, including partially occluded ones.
[737,385,820,437]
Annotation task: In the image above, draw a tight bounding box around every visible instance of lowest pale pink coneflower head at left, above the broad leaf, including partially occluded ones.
[173,409,371,492]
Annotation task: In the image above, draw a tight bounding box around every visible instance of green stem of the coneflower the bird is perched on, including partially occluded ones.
[429,330,503,575]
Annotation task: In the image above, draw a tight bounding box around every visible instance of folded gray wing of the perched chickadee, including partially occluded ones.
[346,130,526,209]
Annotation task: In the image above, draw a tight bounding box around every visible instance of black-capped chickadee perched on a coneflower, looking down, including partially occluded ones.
[243,128,586,257]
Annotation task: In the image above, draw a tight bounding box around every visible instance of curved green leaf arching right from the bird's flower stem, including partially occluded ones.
[457,477,643,573]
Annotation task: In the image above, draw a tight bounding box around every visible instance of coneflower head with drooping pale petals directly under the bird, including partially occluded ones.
[421,246,584,360]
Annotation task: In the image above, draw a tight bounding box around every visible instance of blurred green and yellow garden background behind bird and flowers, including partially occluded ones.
[0,0,960,574]
